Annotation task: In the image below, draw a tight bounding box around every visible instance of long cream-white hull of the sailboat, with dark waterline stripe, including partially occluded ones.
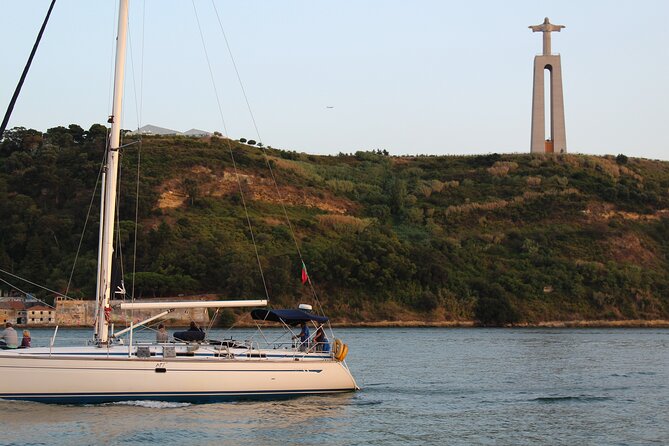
[0,346,357,404]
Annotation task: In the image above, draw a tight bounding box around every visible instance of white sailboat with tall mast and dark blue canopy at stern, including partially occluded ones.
[0,0,357,404]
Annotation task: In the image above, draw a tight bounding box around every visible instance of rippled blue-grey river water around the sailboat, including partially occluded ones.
[0,328,669,445]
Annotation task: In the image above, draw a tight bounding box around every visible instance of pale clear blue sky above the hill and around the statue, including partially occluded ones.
[0,0,669,160]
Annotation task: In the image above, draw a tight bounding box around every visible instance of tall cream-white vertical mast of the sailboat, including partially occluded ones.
[95,0,129,345]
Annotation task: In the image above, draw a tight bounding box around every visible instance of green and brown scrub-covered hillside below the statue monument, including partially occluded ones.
[0,125,669,325]
